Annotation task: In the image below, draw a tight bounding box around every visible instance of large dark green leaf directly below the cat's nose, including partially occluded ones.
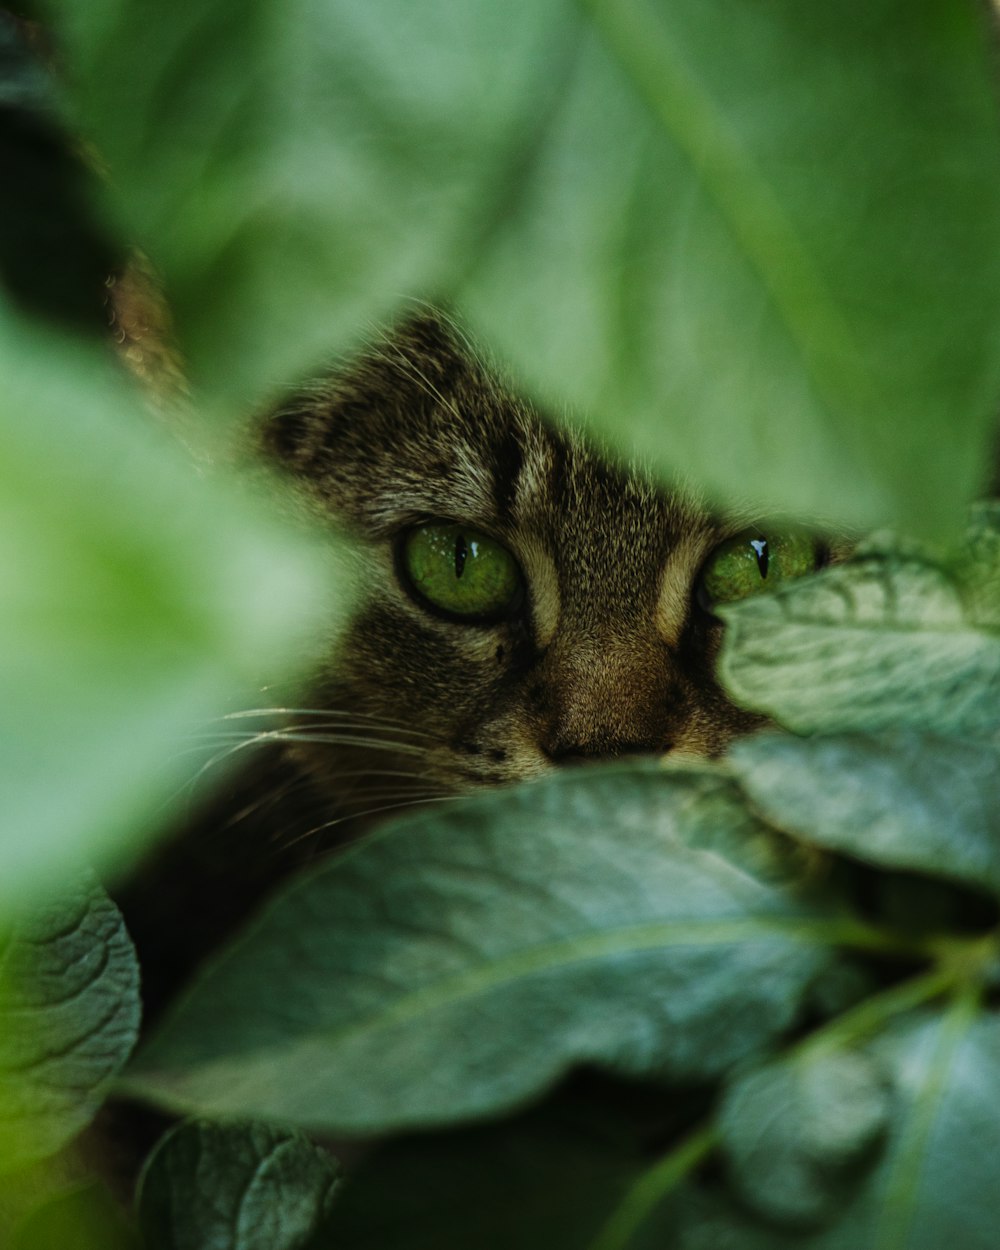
[124,765,830,1131]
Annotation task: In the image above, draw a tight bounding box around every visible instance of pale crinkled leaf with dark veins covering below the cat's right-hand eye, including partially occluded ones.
[720,550,1000,736]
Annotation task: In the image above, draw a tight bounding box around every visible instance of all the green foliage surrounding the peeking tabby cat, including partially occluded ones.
[0,0,1000,1250]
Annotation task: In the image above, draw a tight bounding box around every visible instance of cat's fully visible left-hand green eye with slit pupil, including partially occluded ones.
[400,521,521,620]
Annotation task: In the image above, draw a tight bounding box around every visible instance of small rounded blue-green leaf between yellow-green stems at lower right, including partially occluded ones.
[719,1050,889,1226]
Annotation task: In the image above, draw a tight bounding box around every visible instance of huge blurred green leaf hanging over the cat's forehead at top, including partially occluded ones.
[39,0,1000,528]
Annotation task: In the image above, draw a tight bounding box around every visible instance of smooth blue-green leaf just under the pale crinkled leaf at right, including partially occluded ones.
[728,731,1000,891]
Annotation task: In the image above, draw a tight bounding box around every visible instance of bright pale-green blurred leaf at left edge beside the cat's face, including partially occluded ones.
[0,301,346,906]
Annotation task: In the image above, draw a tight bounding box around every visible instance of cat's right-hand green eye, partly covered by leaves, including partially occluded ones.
[699,530,820,608]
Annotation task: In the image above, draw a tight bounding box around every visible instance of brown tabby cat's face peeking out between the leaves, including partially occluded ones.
[265,316,785,810]
